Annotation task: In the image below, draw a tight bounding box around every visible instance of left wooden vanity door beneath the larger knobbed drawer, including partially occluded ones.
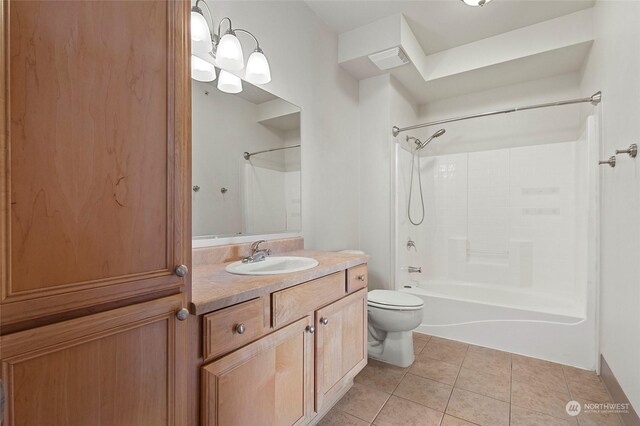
[202,317,313,426]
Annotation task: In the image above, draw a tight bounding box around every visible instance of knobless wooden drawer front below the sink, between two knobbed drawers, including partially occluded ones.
[271,271,345,327]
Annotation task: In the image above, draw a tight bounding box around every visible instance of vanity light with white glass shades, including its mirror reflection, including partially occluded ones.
[191,0,271,93]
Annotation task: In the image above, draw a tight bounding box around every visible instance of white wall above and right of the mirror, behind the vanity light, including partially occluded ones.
[210,1,359,250]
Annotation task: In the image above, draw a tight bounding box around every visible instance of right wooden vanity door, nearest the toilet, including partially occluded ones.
[315,289,367,411]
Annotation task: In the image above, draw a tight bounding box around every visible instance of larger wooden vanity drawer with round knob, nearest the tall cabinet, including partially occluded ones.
[202,297,268,360]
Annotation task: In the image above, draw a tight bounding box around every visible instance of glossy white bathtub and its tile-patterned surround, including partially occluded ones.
[396,113,598,370]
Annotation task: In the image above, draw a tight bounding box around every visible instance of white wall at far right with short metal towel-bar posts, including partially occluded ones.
[582,1,640,411]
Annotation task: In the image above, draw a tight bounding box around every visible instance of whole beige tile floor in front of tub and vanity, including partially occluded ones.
[320,333,622,426]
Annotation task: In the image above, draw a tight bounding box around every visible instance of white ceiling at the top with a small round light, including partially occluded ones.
[305,0,595,55]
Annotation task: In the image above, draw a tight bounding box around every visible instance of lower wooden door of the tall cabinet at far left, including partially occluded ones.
[0,295,187,426]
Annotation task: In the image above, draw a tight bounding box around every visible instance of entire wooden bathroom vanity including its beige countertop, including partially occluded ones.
[190,243,368,426]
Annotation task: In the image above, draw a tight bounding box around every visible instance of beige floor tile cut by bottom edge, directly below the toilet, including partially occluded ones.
[373,396,443,426]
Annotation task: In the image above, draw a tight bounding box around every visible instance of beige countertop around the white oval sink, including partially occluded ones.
[189,250,369,315]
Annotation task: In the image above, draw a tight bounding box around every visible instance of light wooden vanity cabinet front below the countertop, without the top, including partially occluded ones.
[200,264,367,426]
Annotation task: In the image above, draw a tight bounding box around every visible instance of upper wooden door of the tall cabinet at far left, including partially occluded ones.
[0,0,191,326]
